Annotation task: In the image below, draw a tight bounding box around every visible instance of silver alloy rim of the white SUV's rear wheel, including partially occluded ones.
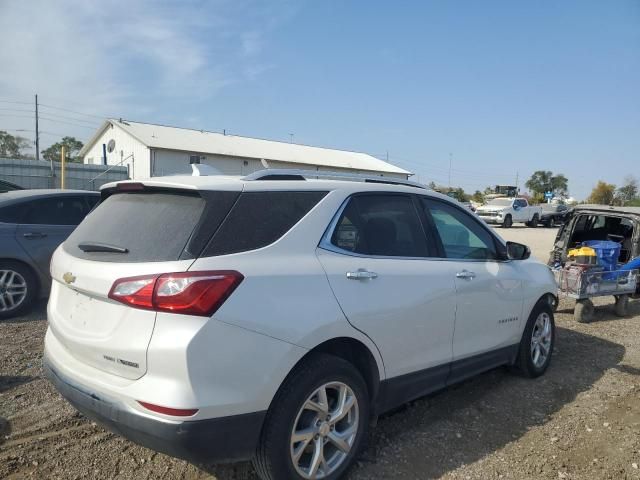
[290,382,360,479]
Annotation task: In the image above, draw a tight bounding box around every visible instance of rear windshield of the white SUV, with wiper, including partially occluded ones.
[64,192,205,262]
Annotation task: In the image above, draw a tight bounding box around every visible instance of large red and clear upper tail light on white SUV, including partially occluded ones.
[109,270,244,317]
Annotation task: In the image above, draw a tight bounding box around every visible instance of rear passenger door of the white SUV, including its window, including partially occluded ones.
[317,193,455,398]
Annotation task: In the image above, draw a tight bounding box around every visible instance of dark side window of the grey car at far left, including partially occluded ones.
[22,196,87,225]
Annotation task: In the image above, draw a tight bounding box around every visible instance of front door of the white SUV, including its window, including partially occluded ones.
[421,197,526,381]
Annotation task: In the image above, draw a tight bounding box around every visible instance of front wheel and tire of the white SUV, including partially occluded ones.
[515,298,556,378]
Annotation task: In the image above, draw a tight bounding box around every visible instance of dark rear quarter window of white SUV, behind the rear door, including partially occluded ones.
[202,192,327,257]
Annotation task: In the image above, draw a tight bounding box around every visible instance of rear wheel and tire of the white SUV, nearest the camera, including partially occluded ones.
[253,354,370,480]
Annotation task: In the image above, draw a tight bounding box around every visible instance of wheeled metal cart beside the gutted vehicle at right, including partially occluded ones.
[553,266,638,323]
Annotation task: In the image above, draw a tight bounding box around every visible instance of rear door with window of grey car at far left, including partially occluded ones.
[16,195,88,275]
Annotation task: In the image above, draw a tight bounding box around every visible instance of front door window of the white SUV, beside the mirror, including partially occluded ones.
[422,198,498,260]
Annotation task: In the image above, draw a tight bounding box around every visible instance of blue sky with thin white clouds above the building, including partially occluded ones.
[0,0,640,198]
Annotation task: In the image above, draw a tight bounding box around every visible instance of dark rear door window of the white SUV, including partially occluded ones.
[331,195,429,257]
